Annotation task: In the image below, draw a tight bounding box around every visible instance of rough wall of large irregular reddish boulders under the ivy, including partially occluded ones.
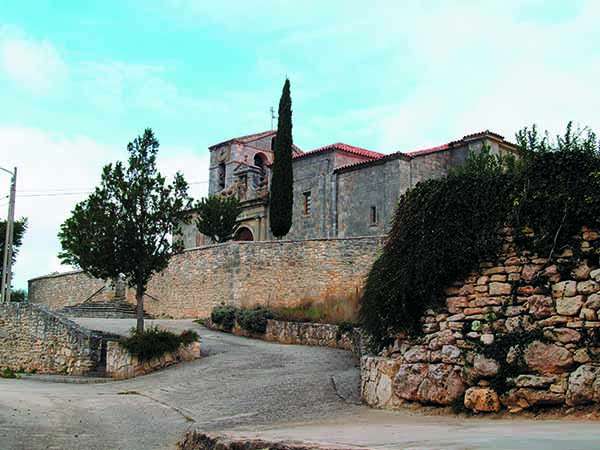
[361,230,600,411]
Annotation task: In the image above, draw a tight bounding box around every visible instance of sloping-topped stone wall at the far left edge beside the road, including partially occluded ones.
[0,303,102,375]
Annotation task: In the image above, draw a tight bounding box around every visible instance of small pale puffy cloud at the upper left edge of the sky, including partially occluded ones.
[0,27,67,94]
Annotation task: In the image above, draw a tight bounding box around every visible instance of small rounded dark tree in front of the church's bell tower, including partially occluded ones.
[195,195,242,242]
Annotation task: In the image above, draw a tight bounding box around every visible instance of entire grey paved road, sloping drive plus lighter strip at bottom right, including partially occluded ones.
[0,319,600,450]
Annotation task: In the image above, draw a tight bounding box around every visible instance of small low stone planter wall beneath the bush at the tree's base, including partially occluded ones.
[106,341,200,380]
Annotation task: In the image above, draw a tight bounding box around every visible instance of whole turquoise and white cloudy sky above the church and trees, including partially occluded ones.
[0,0,600,288]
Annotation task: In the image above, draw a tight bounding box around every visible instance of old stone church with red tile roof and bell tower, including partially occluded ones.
[177,131,518,248]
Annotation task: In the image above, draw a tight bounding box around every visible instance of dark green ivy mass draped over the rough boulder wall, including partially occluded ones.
[359,124,600,348]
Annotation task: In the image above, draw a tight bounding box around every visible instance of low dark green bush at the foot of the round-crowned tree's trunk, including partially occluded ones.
[120,327,198,361]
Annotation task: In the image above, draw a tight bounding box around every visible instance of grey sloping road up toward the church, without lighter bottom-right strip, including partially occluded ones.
[0,319,358,450]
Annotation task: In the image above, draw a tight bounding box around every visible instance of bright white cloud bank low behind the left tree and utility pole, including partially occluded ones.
[0,126,208,288]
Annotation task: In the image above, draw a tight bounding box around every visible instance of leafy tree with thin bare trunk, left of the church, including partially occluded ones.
[59,129,191,332]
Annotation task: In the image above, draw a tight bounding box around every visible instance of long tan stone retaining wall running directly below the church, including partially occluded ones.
[29,237,383,318]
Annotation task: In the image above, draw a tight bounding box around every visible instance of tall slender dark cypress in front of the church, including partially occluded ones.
[269,79,294,238]
